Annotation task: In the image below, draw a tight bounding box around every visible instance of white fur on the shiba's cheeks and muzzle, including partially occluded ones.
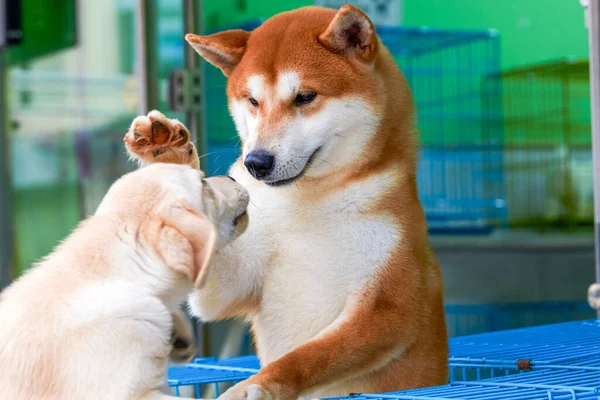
[231,86,381,179]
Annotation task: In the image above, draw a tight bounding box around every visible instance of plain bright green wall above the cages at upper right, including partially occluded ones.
[403,0,588,68]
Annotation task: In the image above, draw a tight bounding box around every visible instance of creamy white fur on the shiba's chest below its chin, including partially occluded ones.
[232,169,401,363]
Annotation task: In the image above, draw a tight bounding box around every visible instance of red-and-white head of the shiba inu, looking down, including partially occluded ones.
[186,5,389,186]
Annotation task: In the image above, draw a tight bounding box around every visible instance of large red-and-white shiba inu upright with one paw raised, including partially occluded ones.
[127,6,448,399]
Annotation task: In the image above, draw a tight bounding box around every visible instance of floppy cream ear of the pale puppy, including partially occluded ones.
[158,206,217,288]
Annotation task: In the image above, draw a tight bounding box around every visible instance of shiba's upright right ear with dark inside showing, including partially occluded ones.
[319,5,378,62]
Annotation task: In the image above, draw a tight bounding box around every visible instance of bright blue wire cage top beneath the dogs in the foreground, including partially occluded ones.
[168,320,600,400]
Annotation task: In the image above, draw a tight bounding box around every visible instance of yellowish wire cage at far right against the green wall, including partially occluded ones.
[489,59,594,229]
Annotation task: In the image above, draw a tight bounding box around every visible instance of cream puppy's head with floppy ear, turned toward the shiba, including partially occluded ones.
[96,164,249,287]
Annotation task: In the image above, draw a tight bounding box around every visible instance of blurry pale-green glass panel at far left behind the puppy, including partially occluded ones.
[9,0,138,272]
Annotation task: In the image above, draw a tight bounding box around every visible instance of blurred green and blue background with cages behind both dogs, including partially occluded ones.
[0,0,595,355]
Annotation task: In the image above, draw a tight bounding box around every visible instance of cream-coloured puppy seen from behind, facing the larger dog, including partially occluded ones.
[0,164,249,400]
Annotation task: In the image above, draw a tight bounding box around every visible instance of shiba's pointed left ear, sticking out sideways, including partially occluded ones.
[185,29,250,76]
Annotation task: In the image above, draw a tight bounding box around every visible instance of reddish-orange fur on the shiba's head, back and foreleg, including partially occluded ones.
[143,6,448,399]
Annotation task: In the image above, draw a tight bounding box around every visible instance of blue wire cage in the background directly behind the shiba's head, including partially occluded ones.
[206,21,506,232]
